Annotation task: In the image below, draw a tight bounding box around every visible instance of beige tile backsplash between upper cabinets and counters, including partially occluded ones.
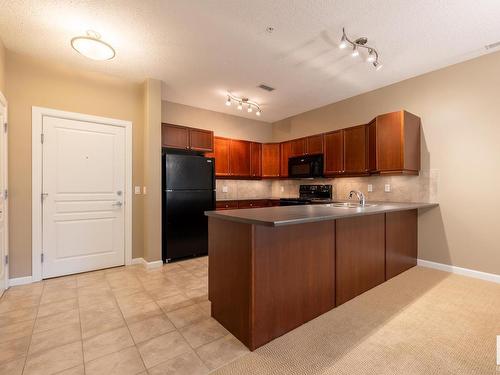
[217,169,439,202]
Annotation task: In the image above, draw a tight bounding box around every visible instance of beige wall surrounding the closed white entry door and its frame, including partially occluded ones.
[5,51,144,278]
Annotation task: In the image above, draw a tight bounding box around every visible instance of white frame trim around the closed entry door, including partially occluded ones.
[31,107,132,281]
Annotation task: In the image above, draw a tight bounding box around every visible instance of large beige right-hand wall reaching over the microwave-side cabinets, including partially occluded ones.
[273,53,500,274]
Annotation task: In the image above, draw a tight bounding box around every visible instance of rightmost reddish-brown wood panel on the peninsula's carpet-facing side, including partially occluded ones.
[385,210,418,280]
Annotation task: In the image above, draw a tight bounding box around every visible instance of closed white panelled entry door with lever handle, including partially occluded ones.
[41,116,127,278]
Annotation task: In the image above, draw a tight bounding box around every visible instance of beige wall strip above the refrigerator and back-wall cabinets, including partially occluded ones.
[161,101,272,142]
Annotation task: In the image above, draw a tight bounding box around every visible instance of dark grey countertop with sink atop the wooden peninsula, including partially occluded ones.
[205,202,438,227]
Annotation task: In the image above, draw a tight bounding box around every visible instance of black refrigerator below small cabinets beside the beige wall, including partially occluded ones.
[162,153,215,262]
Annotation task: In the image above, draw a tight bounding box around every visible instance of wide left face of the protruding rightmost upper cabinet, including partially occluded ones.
[376,112,403,172]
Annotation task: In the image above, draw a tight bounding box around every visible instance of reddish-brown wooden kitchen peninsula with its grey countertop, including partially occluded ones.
[206,202,437,350]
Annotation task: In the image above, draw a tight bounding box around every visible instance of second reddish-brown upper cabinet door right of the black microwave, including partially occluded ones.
[344,125,368,174]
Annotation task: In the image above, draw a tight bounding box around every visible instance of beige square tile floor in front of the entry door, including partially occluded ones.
[0,257,248,375]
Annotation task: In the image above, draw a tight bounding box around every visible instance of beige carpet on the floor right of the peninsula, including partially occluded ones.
[213,267,500,375]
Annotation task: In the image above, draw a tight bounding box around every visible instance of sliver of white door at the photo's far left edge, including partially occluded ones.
[0,98,9,296]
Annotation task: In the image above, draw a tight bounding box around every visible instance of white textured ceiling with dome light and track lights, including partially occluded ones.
[0,0,500,121]
